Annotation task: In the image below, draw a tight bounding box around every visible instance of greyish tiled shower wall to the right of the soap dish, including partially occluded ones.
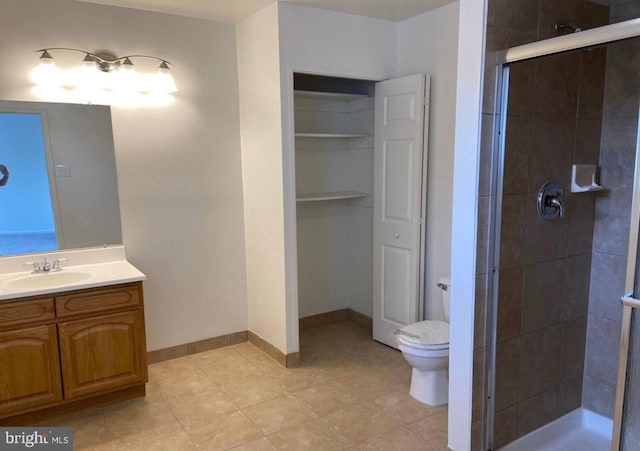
[582,0,640,418]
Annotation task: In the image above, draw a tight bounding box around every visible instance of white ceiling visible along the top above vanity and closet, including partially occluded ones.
[77,0,455,23]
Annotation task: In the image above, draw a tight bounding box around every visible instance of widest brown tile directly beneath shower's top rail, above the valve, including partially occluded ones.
[533,51,580,120]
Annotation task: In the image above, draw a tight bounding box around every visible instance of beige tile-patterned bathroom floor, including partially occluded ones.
[42,321,447,451]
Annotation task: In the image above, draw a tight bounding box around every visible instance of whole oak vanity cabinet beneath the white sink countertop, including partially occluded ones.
[0,282,147,426]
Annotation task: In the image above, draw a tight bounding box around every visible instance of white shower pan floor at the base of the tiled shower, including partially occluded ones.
[499,408,613,451]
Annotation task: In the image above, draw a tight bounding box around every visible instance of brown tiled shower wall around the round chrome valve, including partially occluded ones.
[495,38,608,446]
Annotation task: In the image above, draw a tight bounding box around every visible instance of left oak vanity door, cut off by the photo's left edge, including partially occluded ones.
[0,325,62,417]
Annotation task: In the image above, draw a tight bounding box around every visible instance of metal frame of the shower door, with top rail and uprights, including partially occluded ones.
[483,18,640,451]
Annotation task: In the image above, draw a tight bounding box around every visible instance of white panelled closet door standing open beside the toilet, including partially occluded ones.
[373,74,428,348]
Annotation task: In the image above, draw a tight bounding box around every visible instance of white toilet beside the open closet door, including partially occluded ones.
[396,279,451,406]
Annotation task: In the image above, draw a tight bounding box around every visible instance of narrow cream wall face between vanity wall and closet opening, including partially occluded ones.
[236,4,292,353]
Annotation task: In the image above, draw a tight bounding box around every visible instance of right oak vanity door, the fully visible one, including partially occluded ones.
[58,311,145,399]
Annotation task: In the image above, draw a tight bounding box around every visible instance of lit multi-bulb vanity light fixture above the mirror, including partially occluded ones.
[30,47,178,106]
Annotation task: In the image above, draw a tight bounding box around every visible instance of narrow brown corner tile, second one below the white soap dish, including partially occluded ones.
[562,254,591,320]
